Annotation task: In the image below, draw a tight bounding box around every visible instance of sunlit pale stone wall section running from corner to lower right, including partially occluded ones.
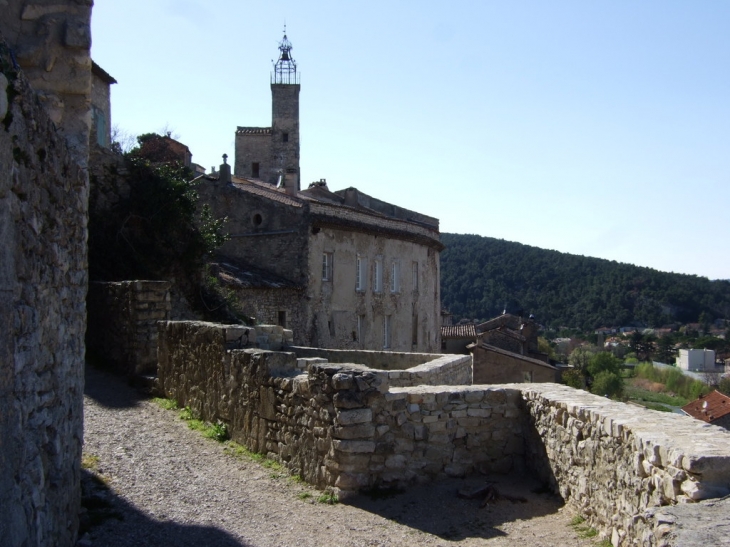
[520,384,730,545]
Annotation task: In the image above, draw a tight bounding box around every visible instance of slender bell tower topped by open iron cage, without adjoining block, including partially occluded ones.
[269,31,301,191]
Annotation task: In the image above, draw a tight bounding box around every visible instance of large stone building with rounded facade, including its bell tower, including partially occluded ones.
[198,35,443,352]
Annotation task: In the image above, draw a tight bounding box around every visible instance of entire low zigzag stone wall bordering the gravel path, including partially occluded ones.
[159,322,730,546]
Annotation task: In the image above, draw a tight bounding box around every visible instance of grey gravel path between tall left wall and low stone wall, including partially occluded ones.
[79,368,593,547]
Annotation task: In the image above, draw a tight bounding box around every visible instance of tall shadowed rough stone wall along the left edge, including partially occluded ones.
[0,36,88,547]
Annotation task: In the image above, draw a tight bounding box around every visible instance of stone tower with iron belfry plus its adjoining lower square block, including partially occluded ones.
[234,31,300,193]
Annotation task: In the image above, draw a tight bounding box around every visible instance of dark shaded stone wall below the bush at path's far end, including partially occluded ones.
[86,281,171,374]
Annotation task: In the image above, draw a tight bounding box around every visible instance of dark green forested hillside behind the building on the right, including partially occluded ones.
[441,234,730,330]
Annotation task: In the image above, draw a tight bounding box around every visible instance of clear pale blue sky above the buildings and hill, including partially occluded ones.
[92,0,730,279]
